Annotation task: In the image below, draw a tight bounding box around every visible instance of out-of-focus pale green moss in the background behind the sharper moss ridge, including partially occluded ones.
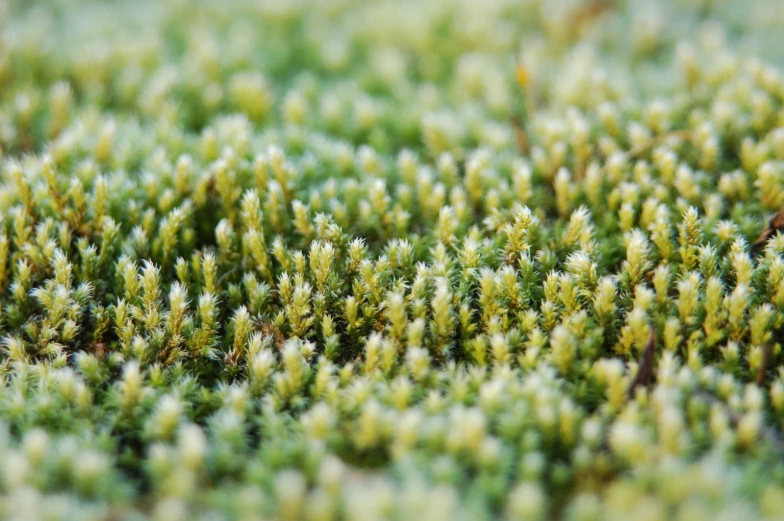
[0,0,784,156]
